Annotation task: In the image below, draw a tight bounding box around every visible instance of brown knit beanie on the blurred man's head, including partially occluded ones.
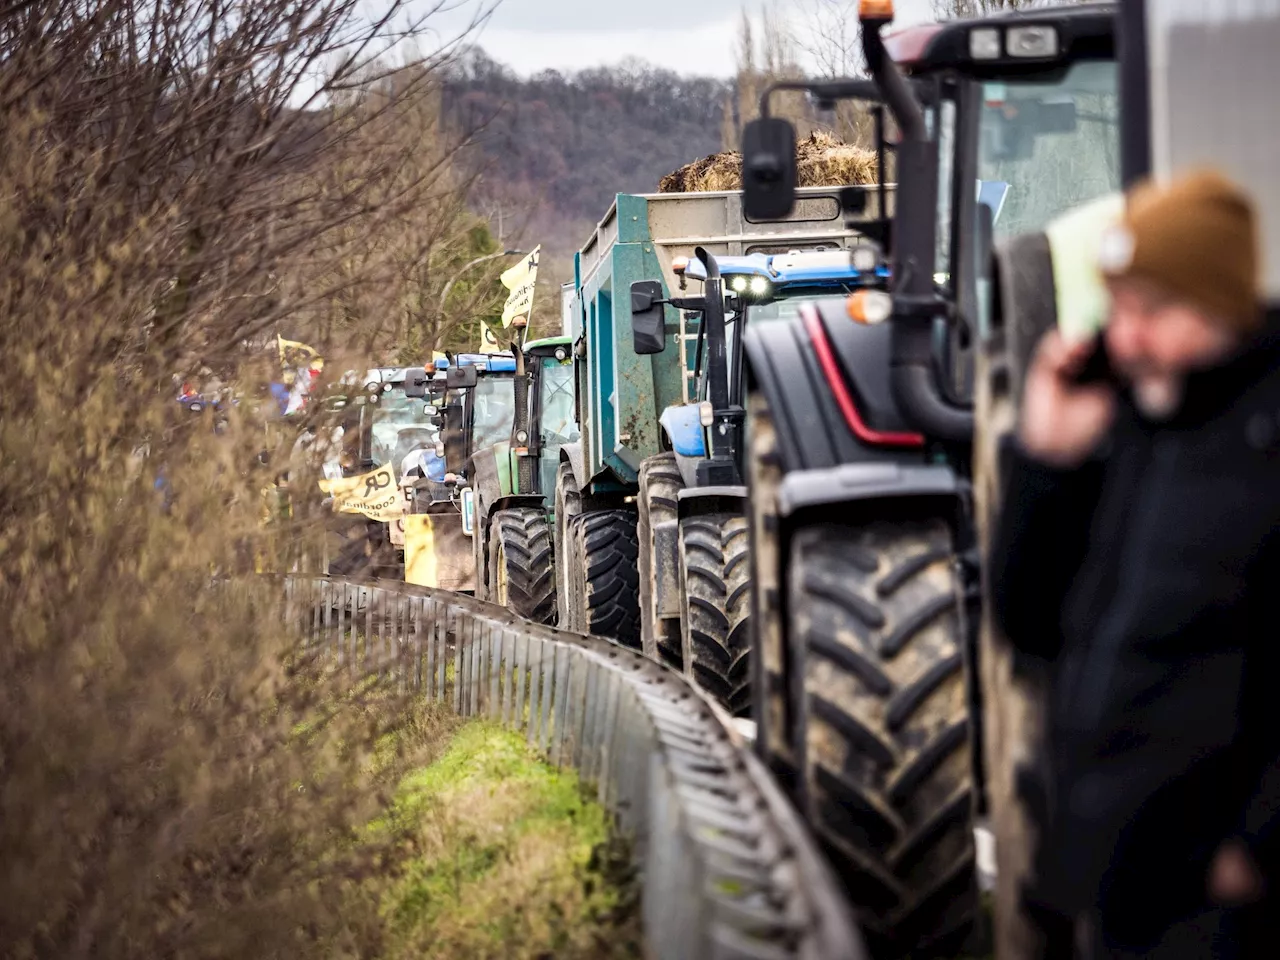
[1098,170,1262,333]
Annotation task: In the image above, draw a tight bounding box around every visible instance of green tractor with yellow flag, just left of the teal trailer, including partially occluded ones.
[463,337,579,623]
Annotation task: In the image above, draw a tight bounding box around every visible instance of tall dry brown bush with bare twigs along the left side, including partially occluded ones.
[0,0,494,957]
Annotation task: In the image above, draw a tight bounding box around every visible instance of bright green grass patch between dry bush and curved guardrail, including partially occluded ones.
[372,721,640,960]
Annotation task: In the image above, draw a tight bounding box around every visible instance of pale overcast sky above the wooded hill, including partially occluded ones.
[417,0,932,77]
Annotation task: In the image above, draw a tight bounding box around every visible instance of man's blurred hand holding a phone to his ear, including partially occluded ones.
[1018,330,1115,468]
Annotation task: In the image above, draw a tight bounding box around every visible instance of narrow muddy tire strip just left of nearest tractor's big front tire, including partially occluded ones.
[746,392,799,778]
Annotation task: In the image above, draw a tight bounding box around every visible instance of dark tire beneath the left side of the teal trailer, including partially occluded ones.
[563,509,640,649]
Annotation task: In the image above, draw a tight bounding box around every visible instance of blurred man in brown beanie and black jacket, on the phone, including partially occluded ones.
[991,173,1280,960]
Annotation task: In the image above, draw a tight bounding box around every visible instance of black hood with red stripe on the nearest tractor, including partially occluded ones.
[742,303,924,474]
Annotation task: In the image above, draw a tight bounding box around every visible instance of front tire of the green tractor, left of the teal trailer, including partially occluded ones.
[488,507,556,623]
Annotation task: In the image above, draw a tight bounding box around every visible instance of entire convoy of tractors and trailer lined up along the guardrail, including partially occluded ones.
[302,0,1280,956]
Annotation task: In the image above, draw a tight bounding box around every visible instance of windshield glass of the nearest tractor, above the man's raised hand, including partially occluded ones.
[978,60,1120,237]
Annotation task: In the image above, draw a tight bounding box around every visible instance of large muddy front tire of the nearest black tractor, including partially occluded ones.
[787,517,978,957]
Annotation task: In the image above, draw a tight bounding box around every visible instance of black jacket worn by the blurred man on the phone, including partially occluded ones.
[991,333,1280,946]
